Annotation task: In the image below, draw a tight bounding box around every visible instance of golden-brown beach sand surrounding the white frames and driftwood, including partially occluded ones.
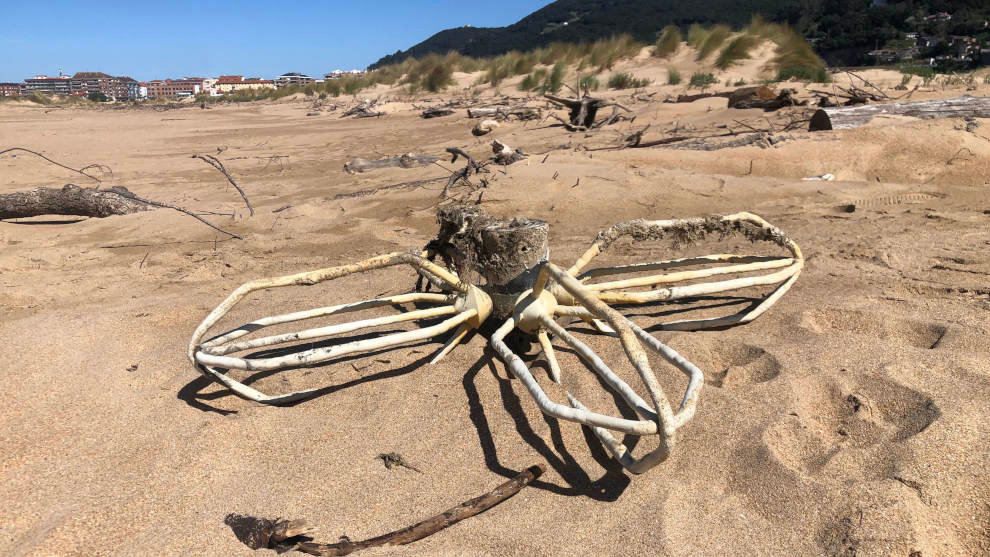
[0,51,990,557]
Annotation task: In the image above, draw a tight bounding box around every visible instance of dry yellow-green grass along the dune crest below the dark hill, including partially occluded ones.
[196,17,828,102]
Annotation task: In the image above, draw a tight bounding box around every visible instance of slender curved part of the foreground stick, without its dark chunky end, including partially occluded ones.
[294,464,546,557]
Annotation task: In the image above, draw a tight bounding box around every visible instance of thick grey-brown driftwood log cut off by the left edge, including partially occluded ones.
[0,184,149,219]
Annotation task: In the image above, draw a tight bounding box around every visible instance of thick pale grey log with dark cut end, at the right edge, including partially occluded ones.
[808,95,990,131]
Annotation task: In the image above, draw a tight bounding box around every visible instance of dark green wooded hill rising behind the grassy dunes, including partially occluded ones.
[369,0,990,69]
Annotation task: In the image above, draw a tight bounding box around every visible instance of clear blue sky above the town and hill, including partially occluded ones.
[0,0,549,81]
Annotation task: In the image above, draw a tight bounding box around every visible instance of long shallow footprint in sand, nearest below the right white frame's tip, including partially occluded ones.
[799,308,946,349]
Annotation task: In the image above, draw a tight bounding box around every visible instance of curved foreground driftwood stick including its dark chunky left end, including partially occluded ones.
[227,464,546,556]
